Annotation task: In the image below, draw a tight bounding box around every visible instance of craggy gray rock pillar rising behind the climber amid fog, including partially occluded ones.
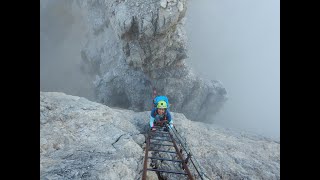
[41,0,227,121]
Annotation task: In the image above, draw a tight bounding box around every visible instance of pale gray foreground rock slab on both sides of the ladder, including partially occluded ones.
[40,92,280,180]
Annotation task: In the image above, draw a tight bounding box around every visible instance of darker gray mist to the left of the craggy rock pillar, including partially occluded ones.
[40,0,94,100]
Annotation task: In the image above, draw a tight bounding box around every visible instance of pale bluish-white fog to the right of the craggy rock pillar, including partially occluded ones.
[186,0,280,140]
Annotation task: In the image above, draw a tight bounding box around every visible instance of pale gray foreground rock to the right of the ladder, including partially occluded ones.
[175,114,280,179]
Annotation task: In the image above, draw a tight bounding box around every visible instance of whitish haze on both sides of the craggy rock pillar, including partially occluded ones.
[40,0,280,139]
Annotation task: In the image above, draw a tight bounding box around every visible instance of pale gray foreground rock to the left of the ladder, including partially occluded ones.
[40,92,147,179]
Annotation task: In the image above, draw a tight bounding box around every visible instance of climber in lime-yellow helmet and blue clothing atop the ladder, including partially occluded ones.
[150,100,173,131]
